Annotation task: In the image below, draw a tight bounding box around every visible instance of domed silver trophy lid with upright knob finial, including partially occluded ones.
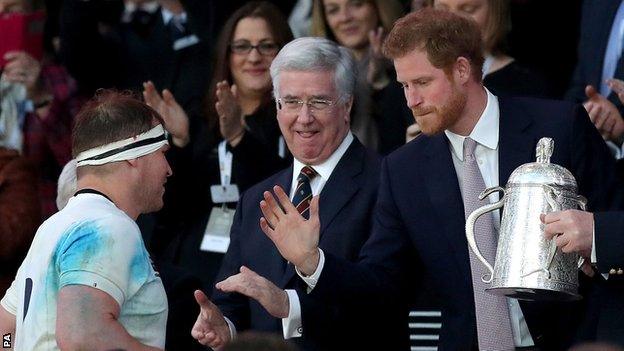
[507,138,577,192]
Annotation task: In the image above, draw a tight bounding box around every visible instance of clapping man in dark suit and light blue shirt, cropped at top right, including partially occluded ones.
[566,0,624,144]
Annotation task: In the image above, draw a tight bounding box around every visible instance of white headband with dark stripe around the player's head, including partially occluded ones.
[76,124,169,167]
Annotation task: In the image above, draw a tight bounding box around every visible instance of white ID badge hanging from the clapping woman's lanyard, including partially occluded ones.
[199,207,236,253]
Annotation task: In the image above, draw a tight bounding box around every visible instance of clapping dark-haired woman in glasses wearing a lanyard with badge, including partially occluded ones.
[143,1,292,292]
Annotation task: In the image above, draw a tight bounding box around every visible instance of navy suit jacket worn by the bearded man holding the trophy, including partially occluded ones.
[311,98,615,350]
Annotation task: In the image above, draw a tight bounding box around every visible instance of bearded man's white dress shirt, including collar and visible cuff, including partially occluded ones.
[297,89,534,347]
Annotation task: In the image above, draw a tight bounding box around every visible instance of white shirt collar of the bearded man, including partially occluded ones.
[444,87,500,161]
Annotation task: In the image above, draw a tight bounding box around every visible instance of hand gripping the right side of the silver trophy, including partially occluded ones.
[540,210,594,260]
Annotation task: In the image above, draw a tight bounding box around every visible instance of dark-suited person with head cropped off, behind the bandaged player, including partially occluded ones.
[60,0,216,121]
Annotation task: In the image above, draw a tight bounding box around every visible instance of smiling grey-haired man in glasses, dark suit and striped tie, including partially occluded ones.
[192,38,408,350]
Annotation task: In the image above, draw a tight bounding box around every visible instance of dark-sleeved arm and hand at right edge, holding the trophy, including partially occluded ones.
[542,210,624,346]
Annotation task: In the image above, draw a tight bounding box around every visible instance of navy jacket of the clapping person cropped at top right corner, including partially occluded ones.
[566,0,624,113]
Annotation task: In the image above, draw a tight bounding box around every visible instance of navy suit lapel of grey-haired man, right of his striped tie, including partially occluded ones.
[280,139,365,288]
